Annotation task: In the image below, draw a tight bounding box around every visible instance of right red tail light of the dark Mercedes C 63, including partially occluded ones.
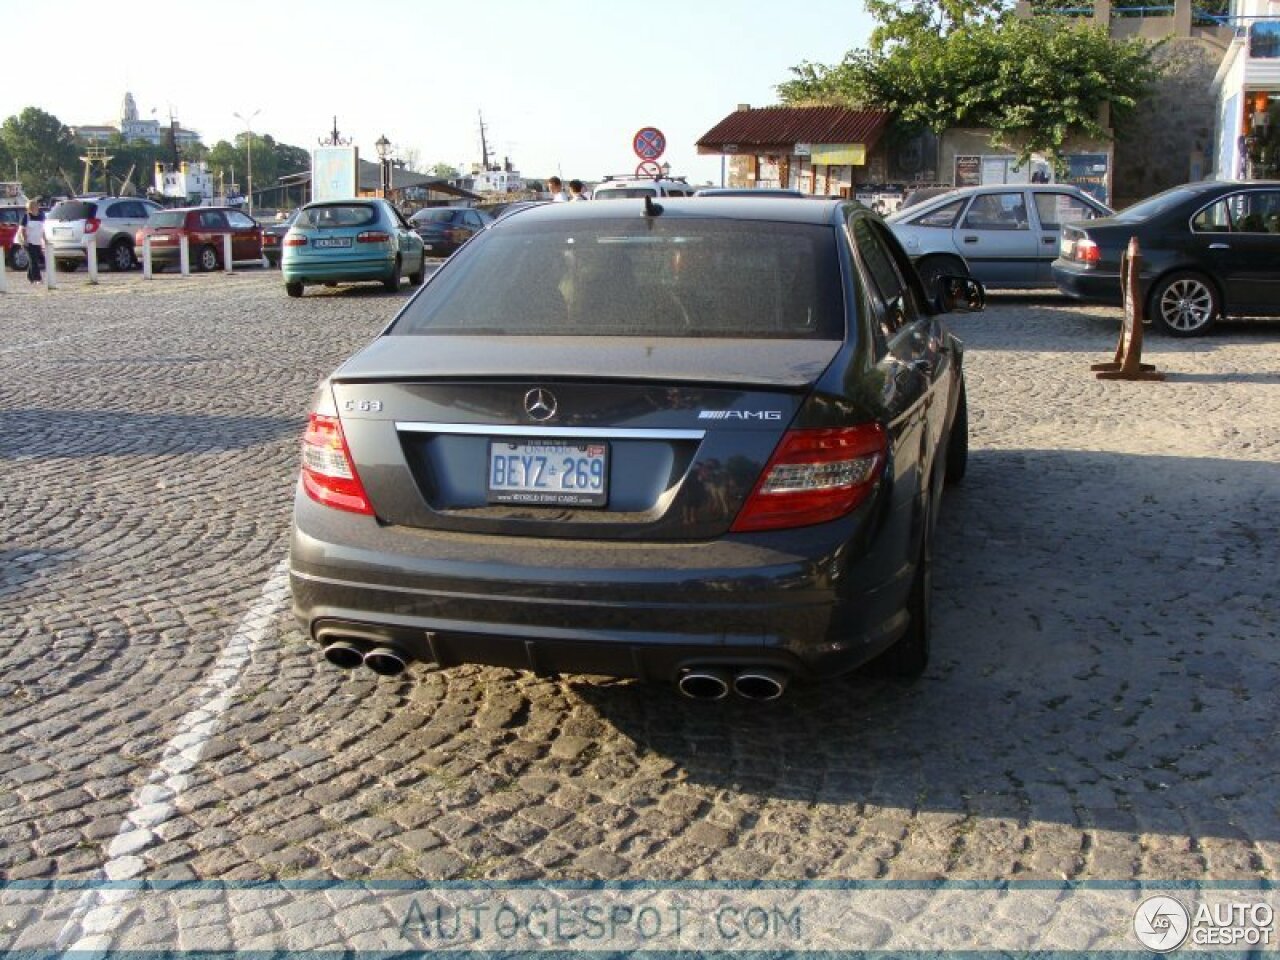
[732,424,888,534]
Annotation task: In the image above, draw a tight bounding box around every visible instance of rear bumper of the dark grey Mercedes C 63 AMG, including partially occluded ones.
[291,493,914,681]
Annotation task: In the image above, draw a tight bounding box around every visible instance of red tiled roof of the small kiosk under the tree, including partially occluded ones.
[698,106,888,154]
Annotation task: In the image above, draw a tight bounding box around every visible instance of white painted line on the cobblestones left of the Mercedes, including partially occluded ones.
[56,559,289,950]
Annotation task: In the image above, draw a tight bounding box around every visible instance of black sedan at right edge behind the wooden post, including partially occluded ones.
[1053,180,1280,337]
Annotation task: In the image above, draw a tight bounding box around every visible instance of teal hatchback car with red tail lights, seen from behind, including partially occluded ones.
[280,198,426,297]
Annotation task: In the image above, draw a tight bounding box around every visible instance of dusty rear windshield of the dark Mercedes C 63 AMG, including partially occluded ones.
[390,216,845,339]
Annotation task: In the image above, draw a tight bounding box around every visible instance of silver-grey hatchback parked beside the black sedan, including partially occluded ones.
[887,183,1111,289]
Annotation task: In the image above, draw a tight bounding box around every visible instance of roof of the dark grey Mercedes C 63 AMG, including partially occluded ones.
[494,196,854,227]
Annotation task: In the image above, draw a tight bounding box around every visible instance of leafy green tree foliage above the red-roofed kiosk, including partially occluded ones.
[778,0,1156,163]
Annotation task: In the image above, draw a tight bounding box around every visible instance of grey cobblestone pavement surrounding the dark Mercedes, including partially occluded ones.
[0,264,1280,896]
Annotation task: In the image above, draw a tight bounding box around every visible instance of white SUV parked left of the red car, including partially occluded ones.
[45,197,163,270]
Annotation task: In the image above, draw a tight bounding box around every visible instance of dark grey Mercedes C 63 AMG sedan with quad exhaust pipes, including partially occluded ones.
[285,198,982,699]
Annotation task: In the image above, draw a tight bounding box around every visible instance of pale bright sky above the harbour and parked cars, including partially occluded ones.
[0,0,872,183]
